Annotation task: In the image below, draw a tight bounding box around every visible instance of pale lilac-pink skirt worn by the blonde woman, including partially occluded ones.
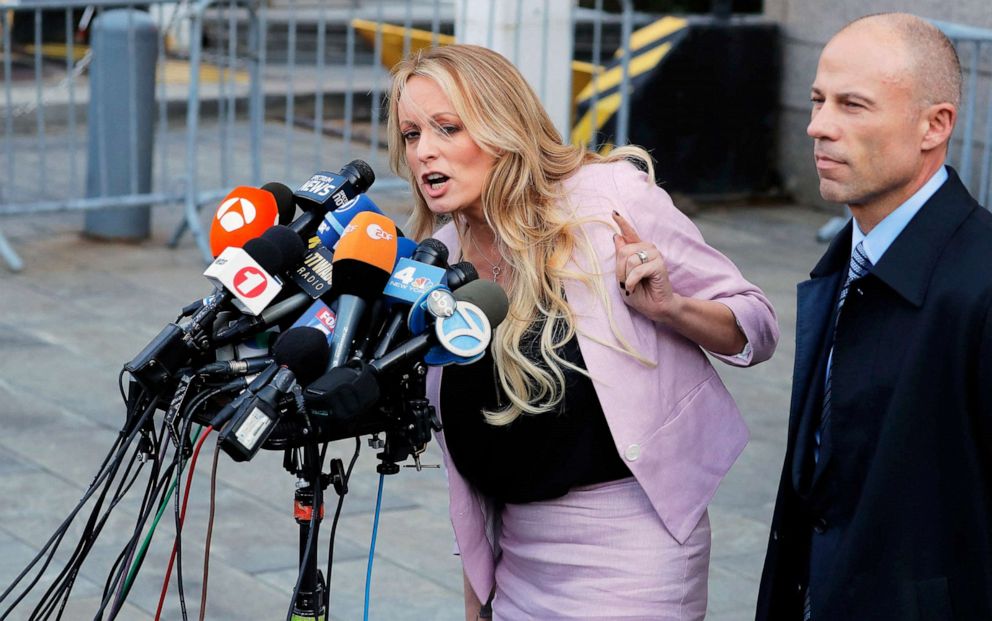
[493,478,710,621]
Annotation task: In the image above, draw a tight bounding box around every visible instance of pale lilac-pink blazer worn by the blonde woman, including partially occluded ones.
[427,162,779,601]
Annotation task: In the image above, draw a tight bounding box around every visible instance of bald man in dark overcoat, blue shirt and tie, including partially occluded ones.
[757,14,992,621]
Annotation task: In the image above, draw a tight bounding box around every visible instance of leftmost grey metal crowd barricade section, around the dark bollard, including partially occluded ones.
[0,0,257,271]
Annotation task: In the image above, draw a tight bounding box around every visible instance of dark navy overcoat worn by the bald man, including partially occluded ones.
[757,169,992,621]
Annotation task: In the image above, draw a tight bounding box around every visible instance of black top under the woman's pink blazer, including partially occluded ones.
[441,320,631,503]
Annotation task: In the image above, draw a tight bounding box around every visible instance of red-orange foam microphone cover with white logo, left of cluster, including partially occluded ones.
[210,185,280,257]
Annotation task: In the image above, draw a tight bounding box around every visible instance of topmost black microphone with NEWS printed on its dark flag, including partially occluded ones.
[290,160,375,239]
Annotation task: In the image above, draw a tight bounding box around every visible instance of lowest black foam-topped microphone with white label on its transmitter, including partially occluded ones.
[217,328,328,461]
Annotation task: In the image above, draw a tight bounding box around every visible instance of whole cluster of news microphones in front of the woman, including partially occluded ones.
[125,160,507,462]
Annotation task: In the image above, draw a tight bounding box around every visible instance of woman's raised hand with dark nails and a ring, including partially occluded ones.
[613,211,683,323]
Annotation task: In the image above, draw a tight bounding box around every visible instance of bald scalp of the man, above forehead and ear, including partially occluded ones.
[834,13,961,108]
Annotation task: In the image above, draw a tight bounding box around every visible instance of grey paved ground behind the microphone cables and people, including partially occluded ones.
[0,151,823,621]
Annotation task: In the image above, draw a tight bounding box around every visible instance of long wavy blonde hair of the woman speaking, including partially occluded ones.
[388,45,654,425]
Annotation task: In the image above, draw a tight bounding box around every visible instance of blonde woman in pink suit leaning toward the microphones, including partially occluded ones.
[389,45,778,619]
